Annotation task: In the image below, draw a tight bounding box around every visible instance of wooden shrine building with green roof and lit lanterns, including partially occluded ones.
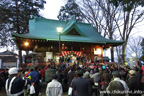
[12,17,124,63]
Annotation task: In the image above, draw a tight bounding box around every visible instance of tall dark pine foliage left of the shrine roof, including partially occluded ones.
[1,0,45,34]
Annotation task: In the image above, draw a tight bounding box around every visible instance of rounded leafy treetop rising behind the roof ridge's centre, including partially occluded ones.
[57,0,84,22]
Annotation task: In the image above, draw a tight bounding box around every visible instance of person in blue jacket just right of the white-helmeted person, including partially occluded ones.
[30,67,41,96]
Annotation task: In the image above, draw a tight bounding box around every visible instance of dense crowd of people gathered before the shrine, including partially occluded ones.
[0,62,144,96]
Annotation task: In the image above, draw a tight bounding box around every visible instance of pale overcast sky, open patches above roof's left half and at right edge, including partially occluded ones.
[40,0,144,38]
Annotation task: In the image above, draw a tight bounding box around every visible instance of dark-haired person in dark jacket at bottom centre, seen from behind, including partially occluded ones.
[72,69,92,96]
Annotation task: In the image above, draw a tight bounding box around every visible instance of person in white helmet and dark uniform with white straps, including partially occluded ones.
[5,67,28,96]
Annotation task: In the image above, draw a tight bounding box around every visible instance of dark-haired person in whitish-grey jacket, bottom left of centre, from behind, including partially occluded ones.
[46,75,63,96]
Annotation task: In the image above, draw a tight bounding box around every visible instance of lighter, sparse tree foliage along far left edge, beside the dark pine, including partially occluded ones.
[0,1,14,48]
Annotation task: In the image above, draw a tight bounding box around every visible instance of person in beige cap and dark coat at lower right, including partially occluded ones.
[128,70,142,96]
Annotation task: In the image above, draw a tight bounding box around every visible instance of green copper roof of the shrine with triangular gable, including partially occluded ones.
[12,17,124,45]
